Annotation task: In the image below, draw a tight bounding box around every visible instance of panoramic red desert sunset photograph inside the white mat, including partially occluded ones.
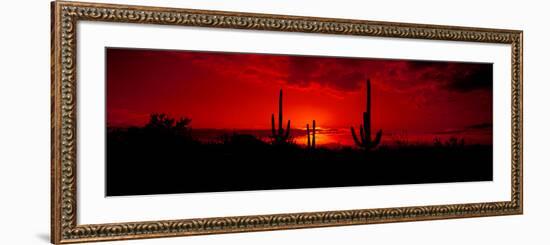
[105,47,493,196]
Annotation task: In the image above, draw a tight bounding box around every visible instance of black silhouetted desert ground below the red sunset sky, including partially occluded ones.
[107,125,493,196]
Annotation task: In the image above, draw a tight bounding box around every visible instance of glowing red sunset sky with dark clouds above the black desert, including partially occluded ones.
[106,48,493,143]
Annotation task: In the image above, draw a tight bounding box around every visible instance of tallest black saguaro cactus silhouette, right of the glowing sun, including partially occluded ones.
[351,79,382,150]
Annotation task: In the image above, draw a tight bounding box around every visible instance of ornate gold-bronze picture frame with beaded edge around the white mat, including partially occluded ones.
[51,1,523,244]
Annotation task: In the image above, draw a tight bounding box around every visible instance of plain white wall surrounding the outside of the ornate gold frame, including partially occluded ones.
[0,0,550,244]
